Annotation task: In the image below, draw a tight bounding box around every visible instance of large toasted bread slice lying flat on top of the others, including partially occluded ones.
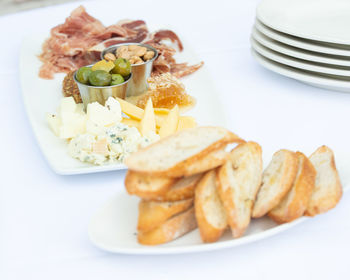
[125,127,244,177]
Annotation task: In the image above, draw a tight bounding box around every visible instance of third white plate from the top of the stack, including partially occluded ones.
[252,27,350,66]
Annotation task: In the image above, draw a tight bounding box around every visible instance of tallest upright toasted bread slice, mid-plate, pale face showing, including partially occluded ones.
[217,142,263,238]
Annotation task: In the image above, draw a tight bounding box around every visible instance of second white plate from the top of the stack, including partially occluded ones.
[255,20,350,56]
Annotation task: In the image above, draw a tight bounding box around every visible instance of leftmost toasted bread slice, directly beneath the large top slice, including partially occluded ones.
[124,170,176,197]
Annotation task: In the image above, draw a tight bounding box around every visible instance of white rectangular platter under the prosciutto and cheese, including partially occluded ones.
[20,33,226,175]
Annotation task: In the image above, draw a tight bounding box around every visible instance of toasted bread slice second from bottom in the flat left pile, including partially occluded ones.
[137,199,193,232]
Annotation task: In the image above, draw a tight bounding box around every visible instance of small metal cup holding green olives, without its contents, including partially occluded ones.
[73,64,132,110]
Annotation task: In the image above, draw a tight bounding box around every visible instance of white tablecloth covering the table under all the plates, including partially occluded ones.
[0,0,350,280]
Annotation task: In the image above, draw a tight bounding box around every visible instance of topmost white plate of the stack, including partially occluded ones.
[257,0,350,45]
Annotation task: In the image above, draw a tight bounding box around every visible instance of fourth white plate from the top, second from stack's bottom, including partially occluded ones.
[251,38,350,77]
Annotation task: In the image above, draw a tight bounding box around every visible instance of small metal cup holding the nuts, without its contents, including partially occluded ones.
[101,43,158,97]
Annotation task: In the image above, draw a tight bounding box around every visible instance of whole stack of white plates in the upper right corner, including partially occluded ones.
[251,0,350,92]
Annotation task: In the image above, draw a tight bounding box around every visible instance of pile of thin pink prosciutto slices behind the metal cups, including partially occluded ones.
[39,6,203,79]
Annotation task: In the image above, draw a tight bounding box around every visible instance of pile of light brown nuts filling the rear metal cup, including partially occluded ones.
[104,45,155,64]
